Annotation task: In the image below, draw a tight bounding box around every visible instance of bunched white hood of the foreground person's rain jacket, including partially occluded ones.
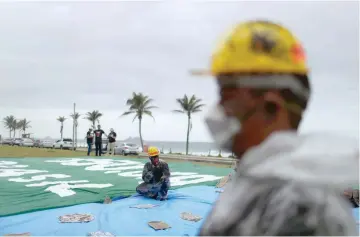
[238,132,359,193]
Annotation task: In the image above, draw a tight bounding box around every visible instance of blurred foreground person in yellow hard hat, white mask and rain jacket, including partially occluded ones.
[191,21,359,236]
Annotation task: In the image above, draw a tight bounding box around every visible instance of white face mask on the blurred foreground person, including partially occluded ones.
[205,105,241,152]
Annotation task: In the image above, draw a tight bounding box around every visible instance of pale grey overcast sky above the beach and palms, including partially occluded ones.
[0,0,359,141]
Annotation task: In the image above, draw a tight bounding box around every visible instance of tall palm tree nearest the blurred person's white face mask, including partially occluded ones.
[173,95,205,155]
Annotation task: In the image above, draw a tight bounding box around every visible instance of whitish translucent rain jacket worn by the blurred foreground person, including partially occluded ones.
[200,131,359,236]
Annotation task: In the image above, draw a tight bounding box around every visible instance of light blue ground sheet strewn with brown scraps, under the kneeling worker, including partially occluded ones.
[0,186,359,236]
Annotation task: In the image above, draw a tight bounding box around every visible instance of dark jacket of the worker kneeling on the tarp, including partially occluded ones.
[142,160,170,183]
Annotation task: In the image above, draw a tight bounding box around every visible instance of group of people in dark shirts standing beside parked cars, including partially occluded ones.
[86,125,117,156]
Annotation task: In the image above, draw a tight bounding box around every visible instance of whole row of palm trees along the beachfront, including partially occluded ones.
[3,92,205,154]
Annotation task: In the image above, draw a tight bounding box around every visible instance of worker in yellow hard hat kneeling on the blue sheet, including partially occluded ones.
[136,147,170,201]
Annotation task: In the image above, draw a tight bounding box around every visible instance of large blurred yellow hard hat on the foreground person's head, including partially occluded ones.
[193,21,308,76]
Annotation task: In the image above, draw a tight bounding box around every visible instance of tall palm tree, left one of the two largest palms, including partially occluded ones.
[121,92,157,149]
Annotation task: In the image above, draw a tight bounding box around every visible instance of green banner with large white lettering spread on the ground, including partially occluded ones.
[0,158,231,216]
